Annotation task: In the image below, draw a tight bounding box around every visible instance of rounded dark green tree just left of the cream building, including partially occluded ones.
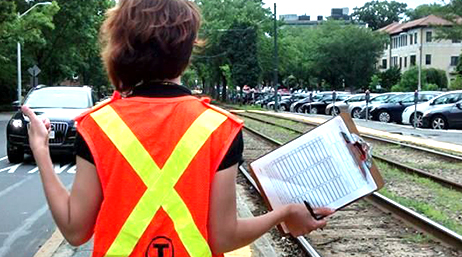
[307,21,386,91]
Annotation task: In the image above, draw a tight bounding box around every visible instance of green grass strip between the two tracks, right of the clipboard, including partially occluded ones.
[377,162,462,234]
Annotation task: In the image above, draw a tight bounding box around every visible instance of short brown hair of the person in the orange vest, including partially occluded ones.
[101,0,201,92]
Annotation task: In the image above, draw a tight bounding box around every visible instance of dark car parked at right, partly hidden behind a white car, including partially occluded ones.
[370,92,440,123]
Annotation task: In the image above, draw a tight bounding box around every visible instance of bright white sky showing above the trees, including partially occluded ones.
[263,0,442,17]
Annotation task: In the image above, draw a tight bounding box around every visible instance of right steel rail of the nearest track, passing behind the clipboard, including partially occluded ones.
[242,123,462,250]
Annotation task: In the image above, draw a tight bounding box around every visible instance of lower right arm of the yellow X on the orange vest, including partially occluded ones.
[162,190,212,257]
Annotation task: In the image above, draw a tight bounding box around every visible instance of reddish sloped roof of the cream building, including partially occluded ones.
[378,14,452,34]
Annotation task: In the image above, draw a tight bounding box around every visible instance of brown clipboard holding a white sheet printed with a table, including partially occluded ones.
[249,113,384,234]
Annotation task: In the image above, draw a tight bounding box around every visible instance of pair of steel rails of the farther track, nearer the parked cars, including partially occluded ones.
[235,110,462,192]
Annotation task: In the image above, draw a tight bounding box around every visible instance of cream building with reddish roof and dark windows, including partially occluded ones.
[378,15,462,82]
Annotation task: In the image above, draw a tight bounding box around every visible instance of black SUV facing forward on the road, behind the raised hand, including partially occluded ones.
[6,86,97,163]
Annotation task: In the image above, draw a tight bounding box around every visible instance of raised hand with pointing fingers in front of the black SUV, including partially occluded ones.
[21,106,50,152]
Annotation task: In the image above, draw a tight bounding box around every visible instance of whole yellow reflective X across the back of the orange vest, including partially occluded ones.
[91,105,227,257]
